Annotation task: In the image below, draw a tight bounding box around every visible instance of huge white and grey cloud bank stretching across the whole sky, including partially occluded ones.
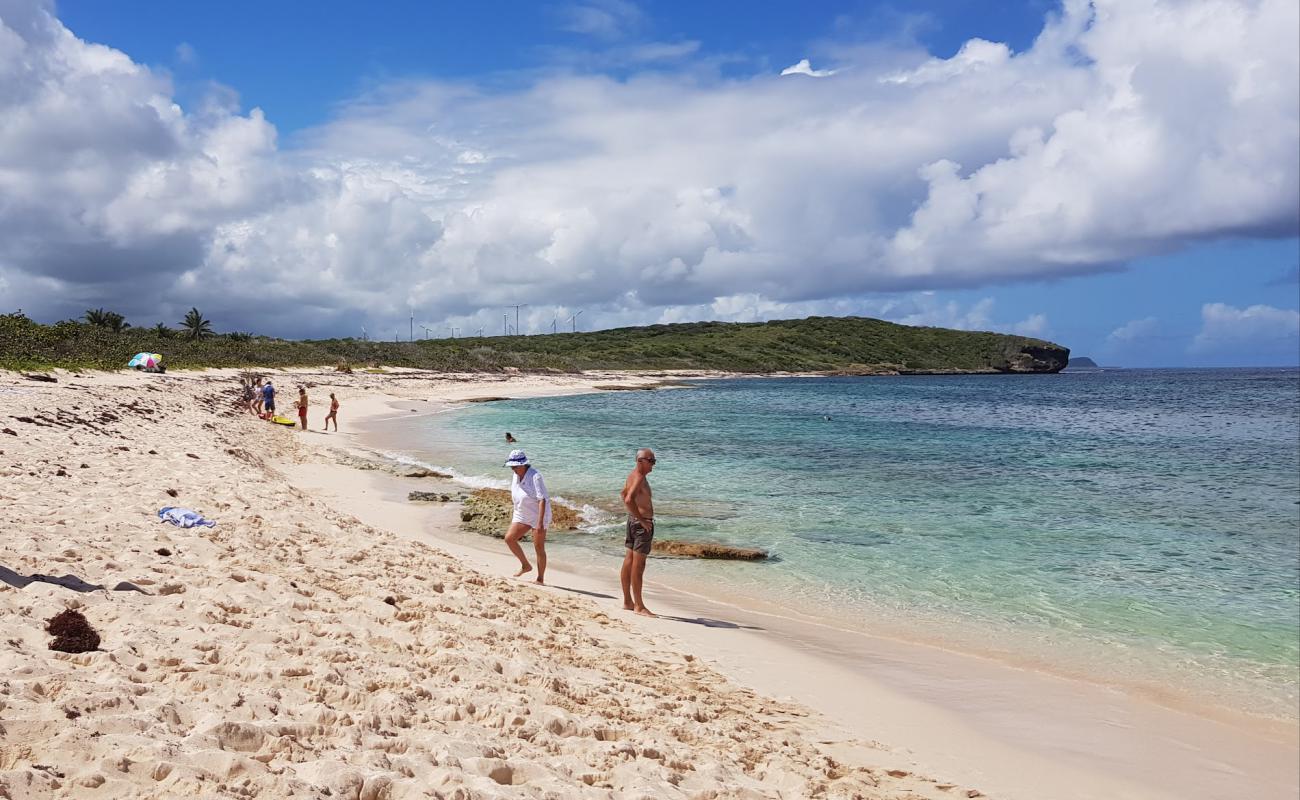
[0,0,1300,334]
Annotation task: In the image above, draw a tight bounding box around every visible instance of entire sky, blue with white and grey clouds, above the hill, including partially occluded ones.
[0,0,1300,367]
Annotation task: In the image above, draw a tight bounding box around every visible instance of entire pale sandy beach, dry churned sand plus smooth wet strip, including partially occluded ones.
[0,371,1297,799]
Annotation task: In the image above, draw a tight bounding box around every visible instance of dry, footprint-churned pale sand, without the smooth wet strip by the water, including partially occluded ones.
[0,371,976,800]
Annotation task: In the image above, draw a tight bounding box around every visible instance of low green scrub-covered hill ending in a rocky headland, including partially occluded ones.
[0,315,1070,373]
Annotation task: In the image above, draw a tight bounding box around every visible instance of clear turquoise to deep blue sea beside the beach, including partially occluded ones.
[366,369,1300,718]
